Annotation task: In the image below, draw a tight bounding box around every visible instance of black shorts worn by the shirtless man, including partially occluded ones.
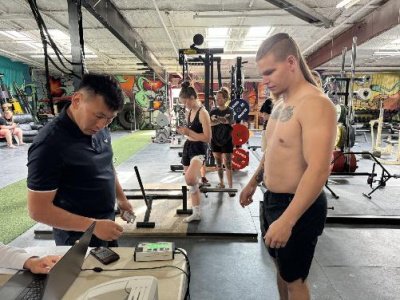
[261,191,327,282]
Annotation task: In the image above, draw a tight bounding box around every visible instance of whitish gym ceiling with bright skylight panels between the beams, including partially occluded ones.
[0,0,400,79]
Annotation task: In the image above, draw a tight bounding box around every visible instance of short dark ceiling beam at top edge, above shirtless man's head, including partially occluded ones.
[266,0,333,28]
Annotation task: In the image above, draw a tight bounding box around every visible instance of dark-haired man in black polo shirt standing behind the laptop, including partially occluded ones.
[28,74,132,247]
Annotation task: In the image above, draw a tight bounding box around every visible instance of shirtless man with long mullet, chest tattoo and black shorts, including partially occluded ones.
[240,33,336,300]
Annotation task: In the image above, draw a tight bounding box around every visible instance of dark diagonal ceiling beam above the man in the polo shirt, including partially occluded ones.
[82,0,165,81]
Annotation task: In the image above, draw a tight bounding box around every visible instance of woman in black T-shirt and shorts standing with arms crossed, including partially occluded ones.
[210,88,235,197]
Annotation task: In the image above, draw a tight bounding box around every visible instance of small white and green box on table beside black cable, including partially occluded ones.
[133,242,175,261]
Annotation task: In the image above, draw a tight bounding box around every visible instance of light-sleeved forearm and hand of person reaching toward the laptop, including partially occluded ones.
[0,243,61,274]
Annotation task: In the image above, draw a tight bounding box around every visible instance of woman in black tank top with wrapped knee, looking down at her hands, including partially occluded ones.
[177,82,211,222]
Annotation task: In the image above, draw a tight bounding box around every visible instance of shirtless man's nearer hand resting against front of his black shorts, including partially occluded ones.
[264,217,293,248]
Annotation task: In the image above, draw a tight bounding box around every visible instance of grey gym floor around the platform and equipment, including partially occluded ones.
[0,129,400,300]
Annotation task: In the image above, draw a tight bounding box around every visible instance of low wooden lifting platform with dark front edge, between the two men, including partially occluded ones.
[35,183,258,241]
